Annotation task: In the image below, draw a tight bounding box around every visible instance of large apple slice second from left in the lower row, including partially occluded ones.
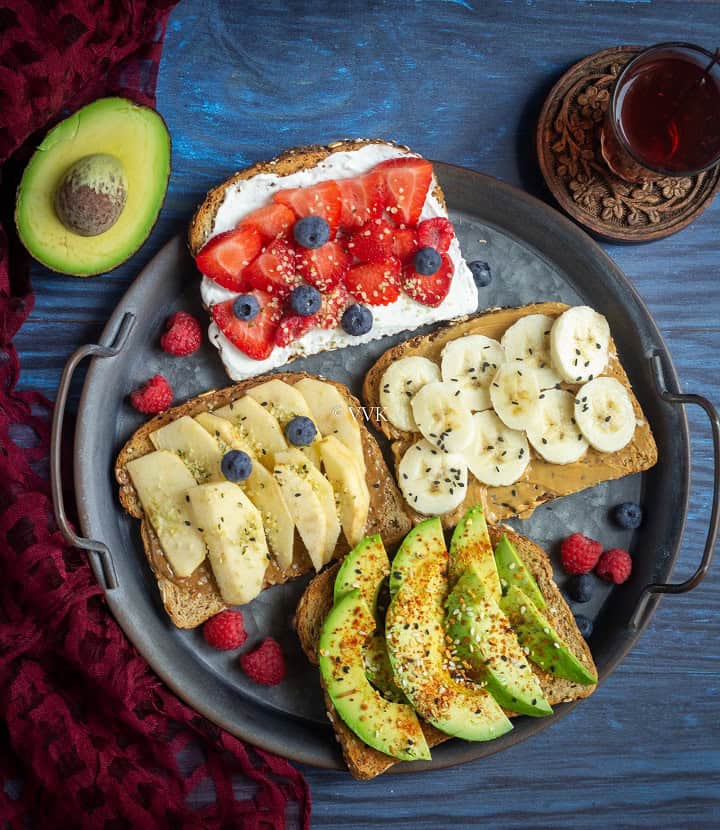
[187,481,269,605]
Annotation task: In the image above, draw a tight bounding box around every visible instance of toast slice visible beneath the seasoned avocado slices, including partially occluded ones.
[295,525,597,781]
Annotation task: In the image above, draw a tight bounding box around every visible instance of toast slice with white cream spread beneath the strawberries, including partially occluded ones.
[188,139,478,380]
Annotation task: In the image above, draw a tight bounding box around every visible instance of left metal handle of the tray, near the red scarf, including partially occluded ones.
[50,312,135,590]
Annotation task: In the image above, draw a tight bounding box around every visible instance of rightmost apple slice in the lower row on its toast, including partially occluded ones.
[319,435,370,548]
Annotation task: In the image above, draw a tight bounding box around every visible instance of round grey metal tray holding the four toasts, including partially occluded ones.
[53,164,717,772]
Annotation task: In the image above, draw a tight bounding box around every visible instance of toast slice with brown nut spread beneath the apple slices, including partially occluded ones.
[115,372,411,628]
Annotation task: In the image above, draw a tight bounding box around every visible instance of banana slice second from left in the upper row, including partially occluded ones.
[441,334,505,412]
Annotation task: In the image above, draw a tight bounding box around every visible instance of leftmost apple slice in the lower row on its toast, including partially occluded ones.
[126,450,206,577]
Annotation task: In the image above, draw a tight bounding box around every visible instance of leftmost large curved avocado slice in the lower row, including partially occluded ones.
[319,590,430,761]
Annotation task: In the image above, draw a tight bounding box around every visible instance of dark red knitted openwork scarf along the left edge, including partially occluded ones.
[0,0,310,830]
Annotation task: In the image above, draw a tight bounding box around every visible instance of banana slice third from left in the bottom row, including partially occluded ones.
[527,389,588,464]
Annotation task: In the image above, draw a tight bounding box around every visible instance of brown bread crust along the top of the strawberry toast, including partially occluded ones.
[188,138,445,256]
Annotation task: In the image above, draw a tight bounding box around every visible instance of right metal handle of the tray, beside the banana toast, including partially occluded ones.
[630,351,720,629]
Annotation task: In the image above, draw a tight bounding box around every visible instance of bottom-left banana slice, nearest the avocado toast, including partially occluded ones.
[398,439,467,516]
